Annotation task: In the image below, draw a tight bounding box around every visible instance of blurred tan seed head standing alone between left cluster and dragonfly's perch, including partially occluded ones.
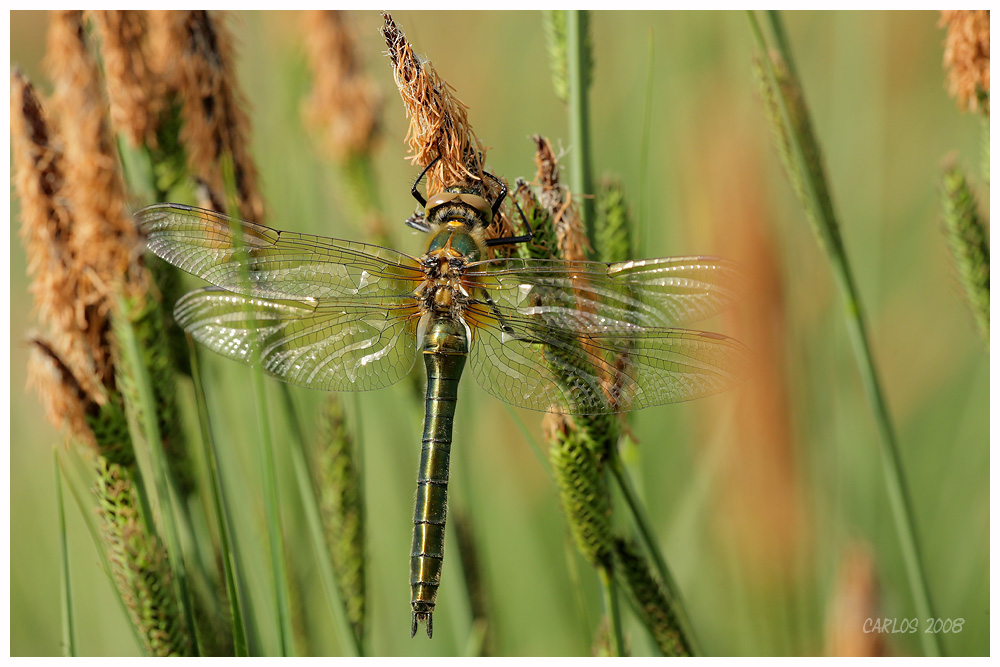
[302,11,383,161]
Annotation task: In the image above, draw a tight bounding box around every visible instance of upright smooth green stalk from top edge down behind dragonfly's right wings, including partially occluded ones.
[566,10,594,250]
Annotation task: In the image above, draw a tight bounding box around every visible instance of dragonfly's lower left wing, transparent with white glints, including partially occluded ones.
[174,287,417,391]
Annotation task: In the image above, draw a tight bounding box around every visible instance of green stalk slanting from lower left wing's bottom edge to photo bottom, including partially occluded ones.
[279,383,365,658]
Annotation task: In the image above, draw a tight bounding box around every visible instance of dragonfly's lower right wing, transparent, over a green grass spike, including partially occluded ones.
[466,292,748,414]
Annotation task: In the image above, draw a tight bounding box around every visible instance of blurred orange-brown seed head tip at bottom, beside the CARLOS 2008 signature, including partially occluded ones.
[826,544,886,657]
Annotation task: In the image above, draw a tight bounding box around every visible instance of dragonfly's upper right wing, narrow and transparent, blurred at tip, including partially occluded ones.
[466,257,742,328]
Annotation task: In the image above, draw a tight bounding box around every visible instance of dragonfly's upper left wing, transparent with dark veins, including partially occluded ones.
[135,204,423,299]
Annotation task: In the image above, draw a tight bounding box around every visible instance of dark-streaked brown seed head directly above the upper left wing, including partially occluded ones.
[149,11,264,222]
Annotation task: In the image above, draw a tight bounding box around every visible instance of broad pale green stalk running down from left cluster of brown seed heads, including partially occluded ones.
[115,297,199,655]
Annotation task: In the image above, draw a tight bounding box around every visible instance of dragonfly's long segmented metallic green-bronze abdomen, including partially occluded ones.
[410,316,469,637]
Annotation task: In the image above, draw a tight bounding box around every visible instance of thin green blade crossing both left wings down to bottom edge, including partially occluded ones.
[222,163,294,657]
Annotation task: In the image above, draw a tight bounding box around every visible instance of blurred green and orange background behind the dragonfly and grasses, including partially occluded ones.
[10,12,990,655]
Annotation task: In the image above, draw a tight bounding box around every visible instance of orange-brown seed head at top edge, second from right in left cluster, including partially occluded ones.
[91,11,166,148]
